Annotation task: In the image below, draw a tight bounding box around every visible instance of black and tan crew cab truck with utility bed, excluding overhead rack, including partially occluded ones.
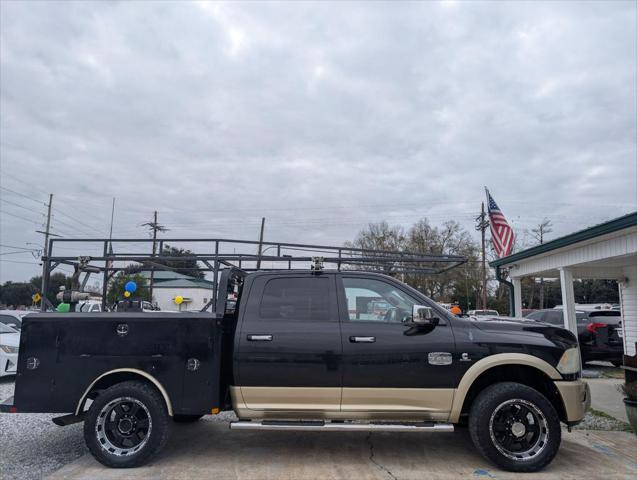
[0,268,590,471]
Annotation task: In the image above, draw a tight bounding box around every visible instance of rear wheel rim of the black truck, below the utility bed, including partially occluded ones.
[95,397,153,456]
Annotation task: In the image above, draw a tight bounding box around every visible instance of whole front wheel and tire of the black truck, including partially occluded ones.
[469,382,562,472]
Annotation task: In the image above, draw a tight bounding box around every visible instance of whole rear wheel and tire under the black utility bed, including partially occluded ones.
[84,381,170,468]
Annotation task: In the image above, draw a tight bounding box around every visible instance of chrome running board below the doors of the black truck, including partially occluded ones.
[230,420,453,432]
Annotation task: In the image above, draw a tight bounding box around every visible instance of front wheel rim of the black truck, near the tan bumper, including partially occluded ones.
[489,399,549,460]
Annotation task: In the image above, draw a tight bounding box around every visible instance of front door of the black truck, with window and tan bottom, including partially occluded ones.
[338,274,458,419]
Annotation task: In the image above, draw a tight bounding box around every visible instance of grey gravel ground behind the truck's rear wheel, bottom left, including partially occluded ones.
[0,377,88,480]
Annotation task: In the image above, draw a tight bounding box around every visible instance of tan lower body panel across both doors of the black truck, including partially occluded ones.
[230,387,454,421]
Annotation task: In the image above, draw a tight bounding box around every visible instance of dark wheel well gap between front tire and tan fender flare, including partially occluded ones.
[461,364,566,422]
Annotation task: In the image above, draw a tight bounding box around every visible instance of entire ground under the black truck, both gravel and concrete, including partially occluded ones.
[0,379,637,480]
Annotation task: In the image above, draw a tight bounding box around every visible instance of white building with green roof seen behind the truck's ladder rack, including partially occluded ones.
[143,270,214,311]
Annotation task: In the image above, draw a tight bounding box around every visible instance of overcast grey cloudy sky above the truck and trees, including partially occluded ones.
[0,1,637,281]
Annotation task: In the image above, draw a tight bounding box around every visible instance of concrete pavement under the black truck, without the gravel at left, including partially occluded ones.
[49,418,637,480]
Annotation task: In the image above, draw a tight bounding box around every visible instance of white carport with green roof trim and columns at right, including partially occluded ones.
[490,212,637,356]
